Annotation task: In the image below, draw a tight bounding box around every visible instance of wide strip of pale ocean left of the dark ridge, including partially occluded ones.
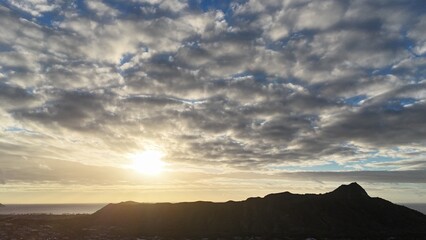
[0,203,106,214]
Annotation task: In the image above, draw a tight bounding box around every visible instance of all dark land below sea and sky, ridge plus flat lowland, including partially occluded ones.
[0,183,426,240]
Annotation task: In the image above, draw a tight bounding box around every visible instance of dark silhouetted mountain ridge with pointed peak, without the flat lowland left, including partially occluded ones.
[90,183,426,238]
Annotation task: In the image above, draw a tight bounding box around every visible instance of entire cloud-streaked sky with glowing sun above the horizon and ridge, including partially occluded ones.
[0,0,426,203]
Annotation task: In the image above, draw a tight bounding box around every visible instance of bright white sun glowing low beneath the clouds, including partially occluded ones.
[130,150,166,175]
